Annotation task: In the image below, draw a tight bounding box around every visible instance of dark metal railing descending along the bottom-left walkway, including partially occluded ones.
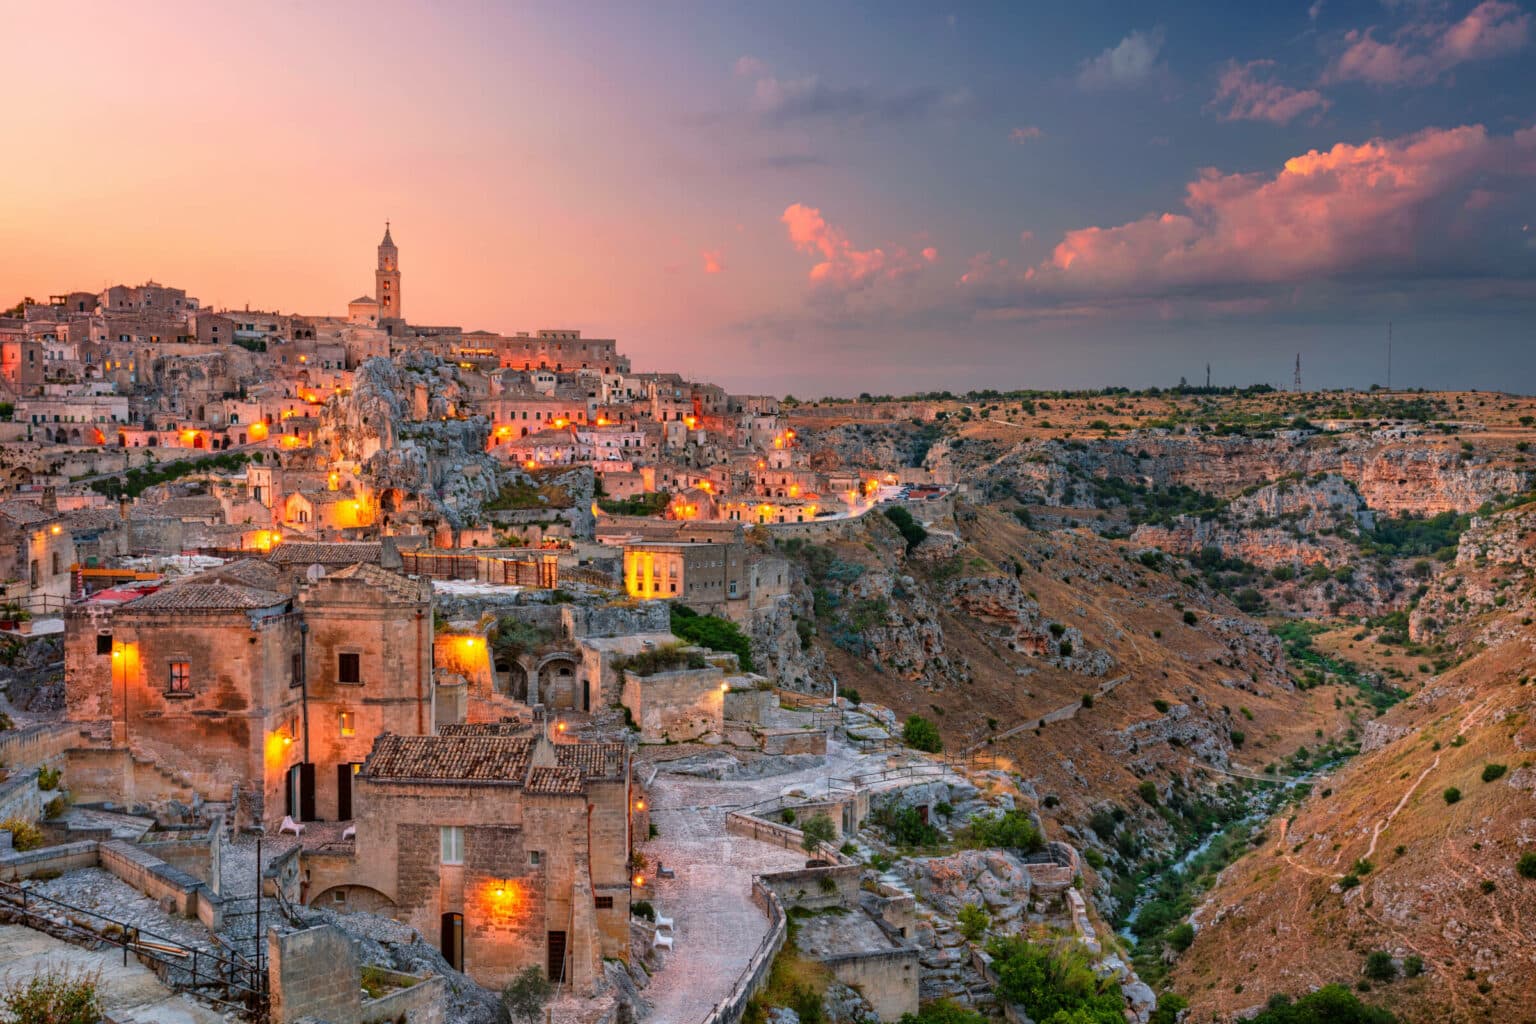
[0,881,267,1021]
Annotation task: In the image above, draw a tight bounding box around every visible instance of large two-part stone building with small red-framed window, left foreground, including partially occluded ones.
[65,560,433,826]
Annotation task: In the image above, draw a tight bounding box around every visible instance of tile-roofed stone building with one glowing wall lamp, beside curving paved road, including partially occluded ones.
[303,725,637,993]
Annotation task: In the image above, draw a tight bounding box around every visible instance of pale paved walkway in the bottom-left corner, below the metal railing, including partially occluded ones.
[0,924,224,1024]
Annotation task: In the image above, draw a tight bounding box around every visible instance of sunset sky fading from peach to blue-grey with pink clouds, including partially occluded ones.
[0,0,1536,398]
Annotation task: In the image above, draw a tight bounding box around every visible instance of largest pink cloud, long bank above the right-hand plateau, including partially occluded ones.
[1007,124,1536,295]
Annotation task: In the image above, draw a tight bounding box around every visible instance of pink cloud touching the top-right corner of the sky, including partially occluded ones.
[1324,0,1531,86]
